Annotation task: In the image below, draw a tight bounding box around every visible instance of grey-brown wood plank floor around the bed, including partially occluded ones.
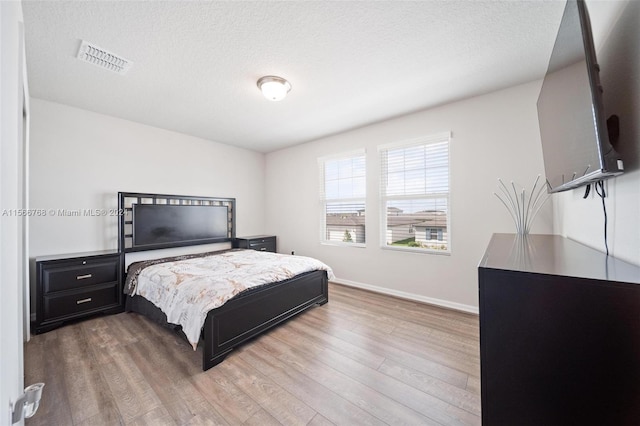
[25,284,480,426]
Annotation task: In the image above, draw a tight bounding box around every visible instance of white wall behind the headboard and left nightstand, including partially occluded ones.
[30,99,264,257]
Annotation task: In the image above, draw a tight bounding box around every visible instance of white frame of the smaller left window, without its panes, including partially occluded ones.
[318,148,367,248]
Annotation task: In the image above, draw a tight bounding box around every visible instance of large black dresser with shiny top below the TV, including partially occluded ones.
[478,234,640,426]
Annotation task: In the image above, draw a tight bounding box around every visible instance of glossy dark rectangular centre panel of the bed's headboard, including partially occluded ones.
[133,204,228,246]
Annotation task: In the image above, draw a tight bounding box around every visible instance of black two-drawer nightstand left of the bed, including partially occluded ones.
[34,250,123,334]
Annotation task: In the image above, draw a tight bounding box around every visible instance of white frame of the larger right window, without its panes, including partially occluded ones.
[378,132,452,256]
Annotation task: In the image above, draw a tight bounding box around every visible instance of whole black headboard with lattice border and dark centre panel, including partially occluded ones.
[118,192,236,253]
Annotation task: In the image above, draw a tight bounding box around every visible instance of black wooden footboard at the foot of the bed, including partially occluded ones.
[202,271,329,370]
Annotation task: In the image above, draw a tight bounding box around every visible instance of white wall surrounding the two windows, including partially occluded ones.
[266,82,552,311]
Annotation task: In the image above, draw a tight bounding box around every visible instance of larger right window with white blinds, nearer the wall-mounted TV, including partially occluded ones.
[379,133,451,253]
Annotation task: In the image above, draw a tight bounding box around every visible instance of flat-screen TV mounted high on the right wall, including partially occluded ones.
[537,0,623,192]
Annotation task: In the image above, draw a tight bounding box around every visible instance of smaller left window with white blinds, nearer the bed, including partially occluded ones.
[318,150,367,246]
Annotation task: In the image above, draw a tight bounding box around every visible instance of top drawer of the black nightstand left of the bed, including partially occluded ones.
[42,259,120,294]
